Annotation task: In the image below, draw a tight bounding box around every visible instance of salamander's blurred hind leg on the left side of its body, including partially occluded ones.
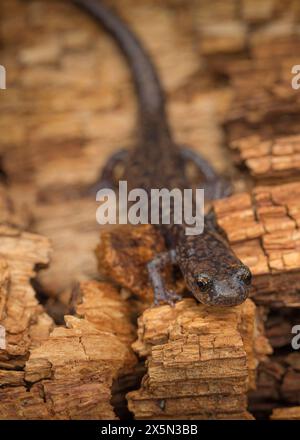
[84,150,129,194]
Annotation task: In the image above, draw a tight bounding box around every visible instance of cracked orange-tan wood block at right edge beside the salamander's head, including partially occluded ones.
[214,183,300,307]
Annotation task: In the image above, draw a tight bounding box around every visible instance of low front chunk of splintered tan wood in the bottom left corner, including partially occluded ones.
[0,317,134,419]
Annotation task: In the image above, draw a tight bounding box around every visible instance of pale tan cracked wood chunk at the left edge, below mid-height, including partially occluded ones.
[0,226,53,368]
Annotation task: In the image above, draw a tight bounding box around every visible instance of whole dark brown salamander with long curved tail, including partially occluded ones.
[73,0,251,306]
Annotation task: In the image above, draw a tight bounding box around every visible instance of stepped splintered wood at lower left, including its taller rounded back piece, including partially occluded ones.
[0,282,136,419]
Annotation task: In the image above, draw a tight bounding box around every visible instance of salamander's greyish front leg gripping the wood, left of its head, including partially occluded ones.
[147,250,181,305]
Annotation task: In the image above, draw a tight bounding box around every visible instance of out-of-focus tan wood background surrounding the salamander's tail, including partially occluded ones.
[0,0,300,420]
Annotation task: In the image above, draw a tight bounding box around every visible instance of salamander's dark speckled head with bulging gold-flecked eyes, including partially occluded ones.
[186,263,252,307]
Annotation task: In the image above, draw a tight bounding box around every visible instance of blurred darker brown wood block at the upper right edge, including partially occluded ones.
[217,19,300,184]
